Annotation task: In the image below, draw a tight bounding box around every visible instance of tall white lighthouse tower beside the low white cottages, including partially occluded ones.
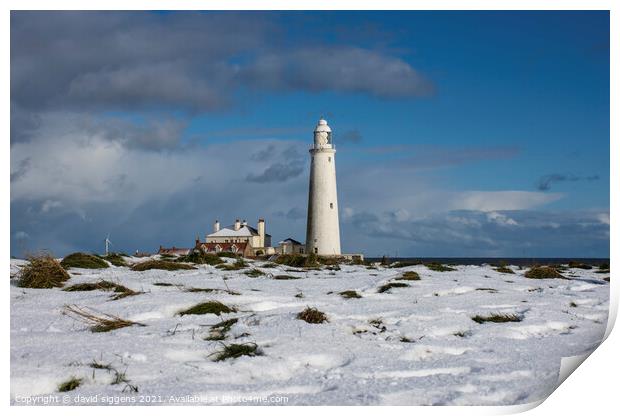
[306,119,340,256]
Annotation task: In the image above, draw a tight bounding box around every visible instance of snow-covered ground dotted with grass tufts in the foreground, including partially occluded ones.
[11,259,609,405]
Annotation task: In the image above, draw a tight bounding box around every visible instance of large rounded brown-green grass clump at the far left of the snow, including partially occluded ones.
[17,254,71,289]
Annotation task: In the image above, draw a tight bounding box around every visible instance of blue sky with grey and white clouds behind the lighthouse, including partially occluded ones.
[10,11,610,257]
